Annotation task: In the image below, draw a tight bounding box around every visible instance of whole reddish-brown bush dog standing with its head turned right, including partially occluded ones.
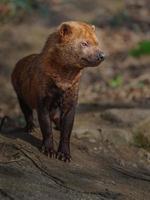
[12,21,104,161]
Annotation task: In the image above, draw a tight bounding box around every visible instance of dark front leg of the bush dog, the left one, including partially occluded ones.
[37,99,55,157]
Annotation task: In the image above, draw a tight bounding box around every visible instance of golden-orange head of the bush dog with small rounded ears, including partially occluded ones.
[55,21,105,68]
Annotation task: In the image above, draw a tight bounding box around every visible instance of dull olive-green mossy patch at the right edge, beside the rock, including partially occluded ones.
[134,132,150,150]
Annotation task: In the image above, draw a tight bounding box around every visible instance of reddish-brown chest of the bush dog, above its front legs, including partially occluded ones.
[43,72,81,111]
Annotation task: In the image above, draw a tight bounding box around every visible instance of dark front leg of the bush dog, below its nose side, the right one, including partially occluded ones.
[57,103,76,162]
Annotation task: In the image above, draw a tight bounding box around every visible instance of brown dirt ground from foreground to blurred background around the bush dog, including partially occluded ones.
[0,0,150,200]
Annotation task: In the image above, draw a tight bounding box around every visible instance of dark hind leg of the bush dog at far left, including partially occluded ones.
[18,96,34,133]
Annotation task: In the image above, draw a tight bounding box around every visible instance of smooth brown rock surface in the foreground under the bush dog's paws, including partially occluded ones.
[0,108,150,200]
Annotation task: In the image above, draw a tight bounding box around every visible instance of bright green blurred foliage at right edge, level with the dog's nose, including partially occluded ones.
[129,40,150,57]
